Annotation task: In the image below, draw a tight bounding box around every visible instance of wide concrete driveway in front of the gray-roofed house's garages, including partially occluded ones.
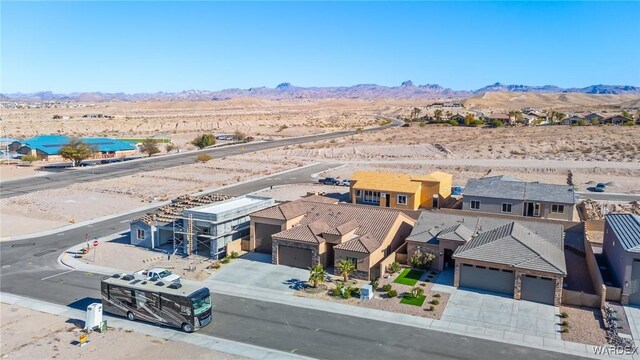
[441,289,560,340]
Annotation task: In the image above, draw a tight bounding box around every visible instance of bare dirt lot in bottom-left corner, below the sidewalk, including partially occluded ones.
[0,303,241,360]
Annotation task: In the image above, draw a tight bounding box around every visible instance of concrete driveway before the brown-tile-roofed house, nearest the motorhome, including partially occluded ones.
[209,253,309,294]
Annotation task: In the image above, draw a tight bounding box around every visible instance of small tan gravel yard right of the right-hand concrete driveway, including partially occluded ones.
[558,306,607,345]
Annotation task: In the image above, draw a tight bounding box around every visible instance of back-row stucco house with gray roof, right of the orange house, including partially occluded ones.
[462,176,577,221]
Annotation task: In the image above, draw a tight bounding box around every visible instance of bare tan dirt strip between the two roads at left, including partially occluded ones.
[0,155,311,236]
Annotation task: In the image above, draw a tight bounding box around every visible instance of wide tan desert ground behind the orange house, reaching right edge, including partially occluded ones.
[269,126,640,193]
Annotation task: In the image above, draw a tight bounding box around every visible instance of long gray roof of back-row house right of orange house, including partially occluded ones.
[462,177,575,204]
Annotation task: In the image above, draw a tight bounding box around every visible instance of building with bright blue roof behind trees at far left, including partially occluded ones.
[17,135,136,161]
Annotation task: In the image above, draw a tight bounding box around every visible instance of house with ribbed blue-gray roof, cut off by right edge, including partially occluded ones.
[602,214,640,305]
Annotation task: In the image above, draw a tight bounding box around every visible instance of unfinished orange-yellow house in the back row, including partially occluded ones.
[349,171,453,210]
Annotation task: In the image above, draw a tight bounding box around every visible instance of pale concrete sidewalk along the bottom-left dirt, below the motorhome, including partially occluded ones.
[0,293,309,360]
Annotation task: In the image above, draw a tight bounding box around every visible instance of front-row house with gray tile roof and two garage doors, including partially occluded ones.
[406,211,567,306]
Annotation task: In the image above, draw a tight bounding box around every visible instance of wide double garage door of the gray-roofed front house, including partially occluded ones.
[460,264,515,295]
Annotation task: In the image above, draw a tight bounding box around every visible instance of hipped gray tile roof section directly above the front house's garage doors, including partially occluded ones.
[454,221,567,275]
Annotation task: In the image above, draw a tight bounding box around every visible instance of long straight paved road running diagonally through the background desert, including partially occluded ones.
[0,119,401,199]
